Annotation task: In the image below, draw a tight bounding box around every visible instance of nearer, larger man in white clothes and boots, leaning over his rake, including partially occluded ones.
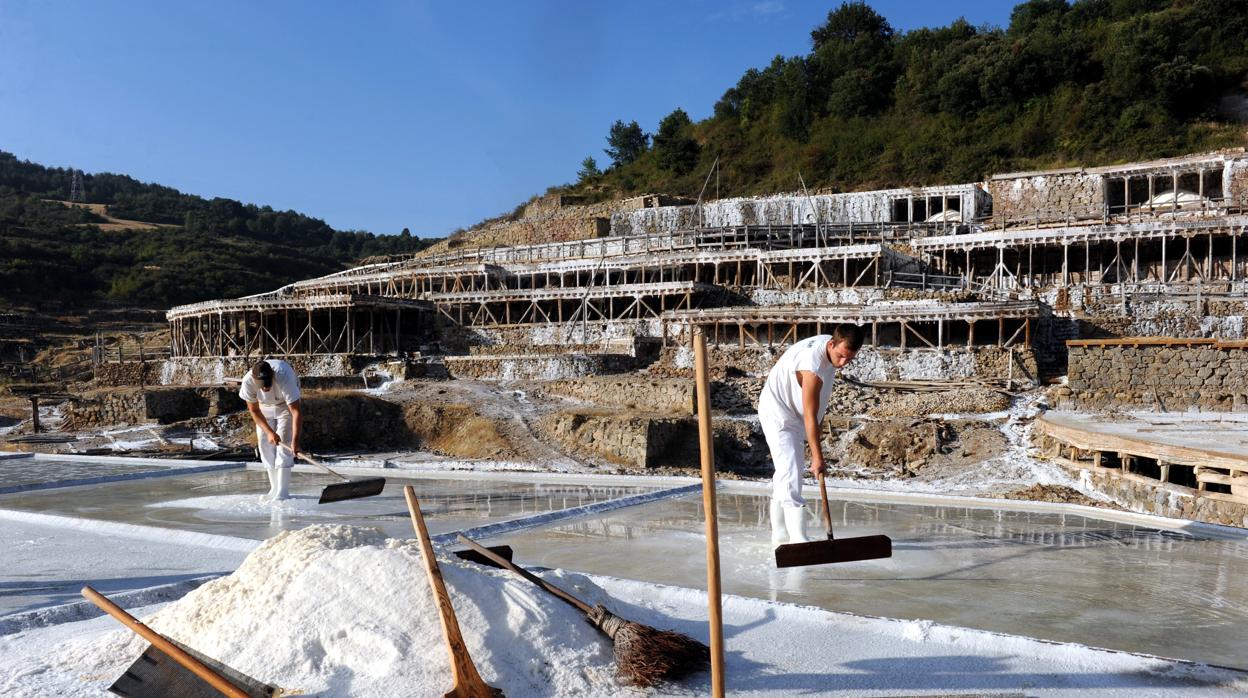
[759,325,862,547]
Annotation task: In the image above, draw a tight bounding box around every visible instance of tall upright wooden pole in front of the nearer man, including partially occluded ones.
[694,330,724,698]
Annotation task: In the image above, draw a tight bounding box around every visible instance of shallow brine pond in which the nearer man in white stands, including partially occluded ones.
[489,492,1248,668]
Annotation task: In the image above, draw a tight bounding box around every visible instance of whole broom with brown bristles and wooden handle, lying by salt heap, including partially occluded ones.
[458,534,710,687]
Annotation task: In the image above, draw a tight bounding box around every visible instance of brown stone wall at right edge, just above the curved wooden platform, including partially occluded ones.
[1060,343,1248,412]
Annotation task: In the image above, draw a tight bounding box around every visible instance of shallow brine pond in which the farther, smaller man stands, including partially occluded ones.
[0,468,660,539]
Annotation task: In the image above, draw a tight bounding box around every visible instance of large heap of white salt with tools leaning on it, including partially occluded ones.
[56,526,620,696]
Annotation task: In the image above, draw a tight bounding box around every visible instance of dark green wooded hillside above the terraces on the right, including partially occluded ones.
[569,0,1248,199]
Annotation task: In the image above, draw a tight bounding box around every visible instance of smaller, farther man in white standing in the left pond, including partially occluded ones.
[238,358,303,503]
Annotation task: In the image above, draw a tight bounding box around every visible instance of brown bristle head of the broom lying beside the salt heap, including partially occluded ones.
[588,606,710,686]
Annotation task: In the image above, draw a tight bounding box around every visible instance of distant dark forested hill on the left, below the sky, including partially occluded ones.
[0,151,434,307]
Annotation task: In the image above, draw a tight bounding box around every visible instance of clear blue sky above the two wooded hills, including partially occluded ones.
[0,0,1013,236]
